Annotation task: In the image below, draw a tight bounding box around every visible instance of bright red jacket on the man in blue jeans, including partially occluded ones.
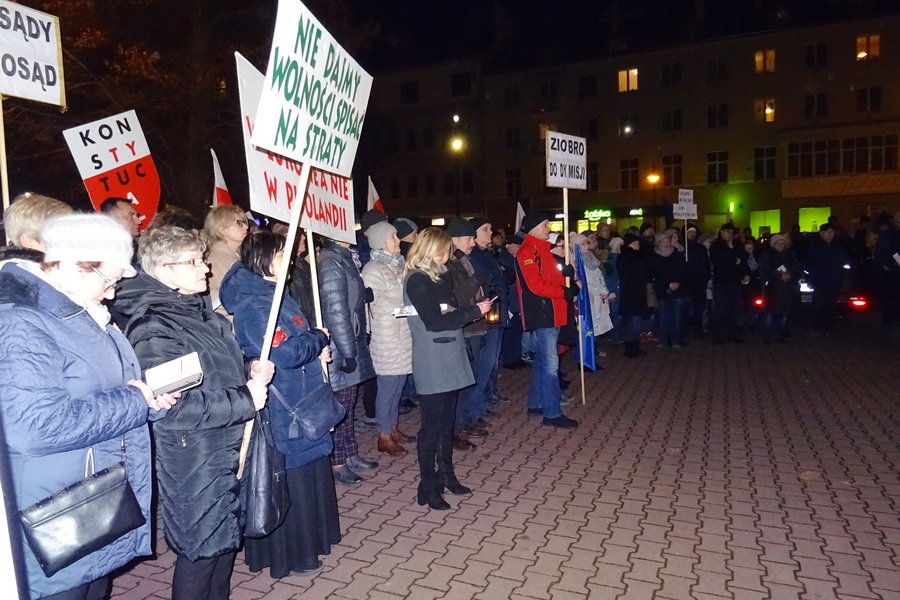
[516,235,568,331]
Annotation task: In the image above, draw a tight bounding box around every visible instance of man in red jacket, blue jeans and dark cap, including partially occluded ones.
[516,212,578,429]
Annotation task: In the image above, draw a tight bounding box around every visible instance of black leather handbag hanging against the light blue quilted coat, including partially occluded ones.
[19,438,147,577]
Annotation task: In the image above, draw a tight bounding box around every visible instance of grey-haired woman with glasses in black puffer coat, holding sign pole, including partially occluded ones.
[115,225,273,600]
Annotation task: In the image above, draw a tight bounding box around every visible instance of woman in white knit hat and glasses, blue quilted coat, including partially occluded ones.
[0,215,177,600]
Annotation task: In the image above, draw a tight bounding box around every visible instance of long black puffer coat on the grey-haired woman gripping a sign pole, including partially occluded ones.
[115,271,256,560]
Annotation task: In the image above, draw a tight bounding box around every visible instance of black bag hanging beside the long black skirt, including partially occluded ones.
[241,409,291,538]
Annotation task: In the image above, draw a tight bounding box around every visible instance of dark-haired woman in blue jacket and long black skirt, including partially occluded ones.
[220,231,341,578]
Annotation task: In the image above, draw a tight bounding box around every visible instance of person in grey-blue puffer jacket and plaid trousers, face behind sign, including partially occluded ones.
[316,239,378,484]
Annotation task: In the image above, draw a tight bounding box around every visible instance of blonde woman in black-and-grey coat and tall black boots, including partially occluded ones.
[403,227,491,510]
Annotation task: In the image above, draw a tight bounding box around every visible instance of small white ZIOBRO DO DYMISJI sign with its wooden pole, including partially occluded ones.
[546,130,587,404]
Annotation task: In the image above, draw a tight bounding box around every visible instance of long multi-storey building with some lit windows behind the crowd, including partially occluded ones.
[361,16,900,235]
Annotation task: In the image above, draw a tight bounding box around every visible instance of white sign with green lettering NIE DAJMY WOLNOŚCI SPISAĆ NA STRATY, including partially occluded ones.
[253,0,372,177]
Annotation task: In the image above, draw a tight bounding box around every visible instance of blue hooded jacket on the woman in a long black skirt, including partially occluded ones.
[219,263,334,469]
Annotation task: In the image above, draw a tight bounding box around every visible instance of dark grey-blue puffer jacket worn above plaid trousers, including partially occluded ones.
[316,240,375,391]
